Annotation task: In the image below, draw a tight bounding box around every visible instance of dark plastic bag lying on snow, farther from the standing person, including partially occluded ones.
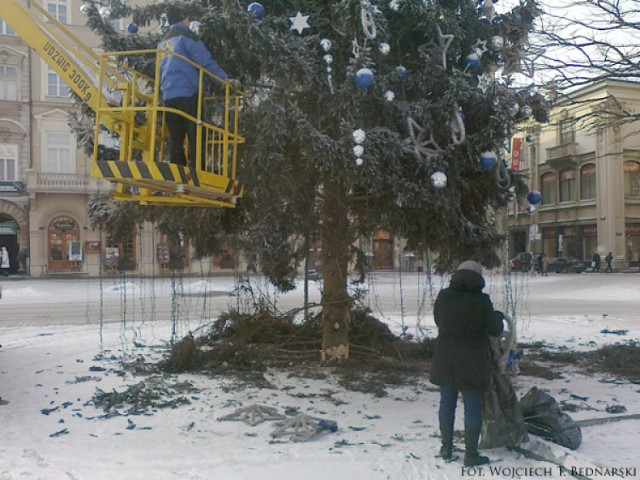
[520,387,582,450]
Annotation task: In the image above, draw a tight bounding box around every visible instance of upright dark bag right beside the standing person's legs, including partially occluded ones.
[478,364,529,449]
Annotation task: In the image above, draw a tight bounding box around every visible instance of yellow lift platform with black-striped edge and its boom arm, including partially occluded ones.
[2,0,244,208]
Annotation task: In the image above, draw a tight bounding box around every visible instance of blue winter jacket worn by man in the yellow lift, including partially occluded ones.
[158,23,227,101]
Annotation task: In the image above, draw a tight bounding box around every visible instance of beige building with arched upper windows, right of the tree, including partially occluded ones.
[508,81,640,269]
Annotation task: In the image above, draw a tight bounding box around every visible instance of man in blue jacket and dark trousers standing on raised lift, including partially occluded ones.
[158,5,227,168]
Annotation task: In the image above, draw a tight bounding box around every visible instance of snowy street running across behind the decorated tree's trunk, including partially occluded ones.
[0,272,640,327]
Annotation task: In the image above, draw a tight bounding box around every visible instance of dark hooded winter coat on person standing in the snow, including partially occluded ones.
[431,270,503,391]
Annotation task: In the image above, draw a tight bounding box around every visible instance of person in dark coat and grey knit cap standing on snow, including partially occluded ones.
[430,260,504,466]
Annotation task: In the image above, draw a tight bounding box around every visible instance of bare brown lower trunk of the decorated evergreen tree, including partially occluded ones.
[321,179,351,362]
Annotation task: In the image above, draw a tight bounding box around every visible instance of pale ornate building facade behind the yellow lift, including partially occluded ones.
[0,0,240,276]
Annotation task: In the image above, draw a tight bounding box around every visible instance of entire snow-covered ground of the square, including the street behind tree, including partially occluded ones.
[0,273,640,480]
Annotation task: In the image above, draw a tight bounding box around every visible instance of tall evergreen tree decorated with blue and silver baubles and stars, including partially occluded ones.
[82,0,547,360]
